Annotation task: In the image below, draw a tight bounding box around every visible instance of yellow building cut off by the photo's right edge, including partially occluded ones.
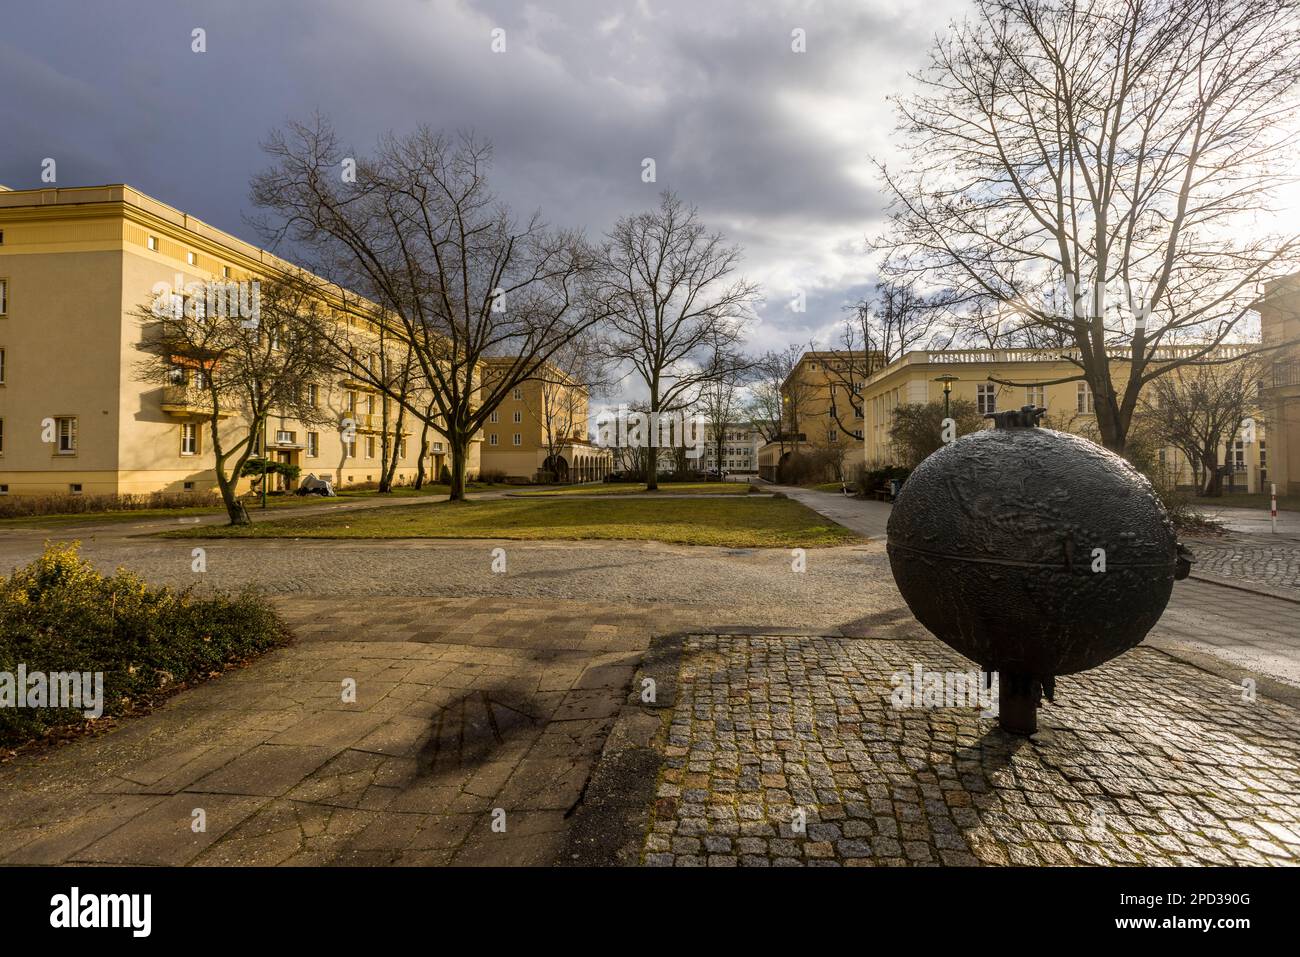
[1255,274,1300,495]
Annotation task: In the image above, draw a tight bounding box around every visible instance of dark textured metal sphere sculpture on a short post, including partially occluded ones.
[888,428,1186,679]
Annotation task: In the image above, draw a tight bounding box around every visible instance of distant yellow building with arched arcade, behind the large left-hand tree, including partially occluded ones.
[480,358,614,482]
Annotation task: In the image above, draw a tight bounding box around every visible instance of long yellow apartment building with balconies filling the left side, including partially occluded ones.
[0,185,478,494]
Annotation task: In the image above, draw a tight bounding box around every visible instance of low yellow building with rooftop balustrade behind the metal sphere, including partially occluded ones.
[862,346,1274,492]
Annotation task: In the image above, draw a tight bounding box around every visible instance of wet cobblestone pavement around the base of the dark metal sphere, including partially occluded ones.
[631,635,1300,866]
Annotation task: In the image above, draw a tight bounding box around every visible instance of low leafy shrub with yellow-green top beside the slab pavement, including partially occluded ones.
[0,542,287,746]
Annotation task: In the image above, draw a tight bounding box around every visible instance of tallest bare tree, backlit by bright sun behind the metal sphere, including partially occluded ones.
[878,0,1300,452]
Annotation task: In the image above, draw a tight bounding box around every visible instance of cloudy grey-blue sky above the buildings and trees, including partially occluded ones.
[0,0,966,350]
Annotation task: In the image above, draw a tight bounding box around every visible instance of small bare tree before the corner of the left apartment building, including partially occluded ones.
[135,277,329,525]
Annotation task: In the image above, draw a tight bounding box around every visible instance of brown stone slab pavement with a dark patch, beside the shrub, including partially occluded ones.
[0,598,712,865]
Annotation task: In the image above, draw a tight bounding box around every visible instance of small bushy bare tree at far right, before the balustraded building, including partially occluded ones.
[1140,359,1264,495]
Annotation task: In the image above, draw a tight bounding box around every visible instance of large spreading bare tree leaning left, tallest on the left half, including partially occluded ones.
[252,117,605,501]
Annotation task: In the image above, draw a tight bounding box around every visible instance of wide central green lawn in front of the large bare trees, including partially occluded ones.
[164,497,862,547]
